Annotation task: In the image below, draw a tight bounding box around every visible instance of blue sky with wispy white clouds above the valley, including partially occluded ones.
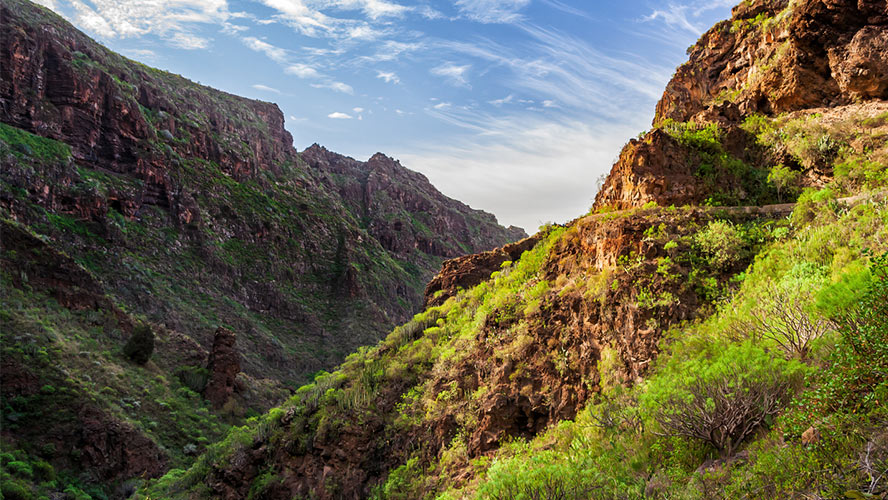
[38,0,738,232]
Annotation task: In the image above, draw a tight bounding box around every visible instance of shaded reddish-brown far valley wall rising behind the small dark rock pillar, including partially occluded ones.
[0,0,525,381]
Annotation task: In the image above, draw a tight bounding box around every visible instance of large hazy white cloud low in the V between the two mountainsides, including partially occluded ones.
[391,108,634,229]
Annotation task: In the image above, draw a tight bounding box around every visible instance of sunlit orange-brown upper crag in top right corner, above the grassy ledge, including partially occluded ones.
[654,0,888,124]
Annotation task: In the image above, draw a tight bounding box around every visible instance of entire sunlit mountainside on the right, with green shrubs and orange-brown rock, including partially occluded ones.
[139,0,888,499]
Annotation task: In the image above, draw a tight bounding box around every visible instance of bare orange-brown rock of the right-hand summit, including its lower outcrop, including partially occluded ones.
[594,0,888,210]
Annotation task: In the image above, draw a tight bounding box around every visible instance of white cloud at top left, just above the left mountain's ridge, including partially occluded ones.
[60,0,231,49]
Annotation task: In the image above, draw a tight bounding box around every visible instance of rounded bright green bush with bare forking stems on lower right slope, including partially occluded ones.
[640,342,803,457]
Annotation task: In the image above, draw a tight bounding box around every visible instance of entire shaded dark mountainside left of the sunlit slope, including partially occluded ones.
[0,0,526,498]
